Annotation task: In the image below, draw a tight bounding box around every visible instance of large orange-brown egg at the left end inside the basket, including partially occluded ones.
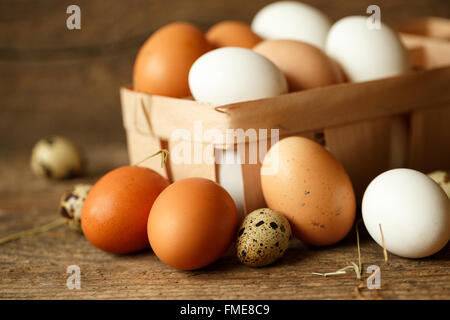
[133,22,211,98]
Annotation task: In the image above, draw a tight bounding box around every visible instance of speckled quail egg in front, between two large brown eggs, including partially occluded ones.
[236,208,291,267]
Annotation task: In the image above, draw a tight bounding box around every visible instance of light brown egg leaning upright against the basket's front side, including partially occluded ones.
[261,137,356,246]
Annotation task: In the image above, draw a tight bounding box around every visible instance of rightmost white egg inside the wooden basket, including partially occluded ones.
[326,16,410,82]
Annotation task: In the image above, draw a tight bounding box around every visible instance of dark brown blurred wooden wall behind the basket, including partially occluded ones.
[0,0,450,156]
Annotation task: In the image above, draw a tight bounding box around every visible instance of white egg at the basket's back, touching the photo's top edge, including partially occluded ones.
[252,1,331,49]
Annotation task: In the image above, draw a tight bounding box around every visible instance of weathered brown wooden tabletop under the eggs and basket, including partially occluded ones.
[0,145,450,299]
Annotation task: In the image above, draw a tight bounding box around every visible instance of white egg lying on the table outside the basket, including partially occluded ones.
[362,169,450,258]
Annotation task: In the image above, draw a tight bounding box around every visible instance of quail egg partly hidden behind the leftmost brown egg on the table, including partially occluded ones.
[59,184,92,232]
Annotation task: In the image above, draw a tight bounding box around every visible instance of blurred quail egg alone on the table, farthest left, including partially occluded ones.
[31,136,83,179]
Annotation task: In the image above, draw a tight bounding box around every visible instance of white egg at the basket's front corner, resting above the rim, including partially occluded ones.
[189,47,288,105]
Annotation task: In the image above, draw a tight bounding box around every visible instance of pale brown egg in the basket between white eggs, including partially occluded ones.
[253,40,343,92]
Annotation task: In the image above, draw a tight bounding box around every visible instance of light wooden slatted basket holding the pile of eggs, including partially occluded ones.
[121,19,450,218]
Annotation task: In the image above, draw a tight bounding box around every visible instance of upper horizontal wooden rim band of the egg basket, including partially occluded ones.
[121,66,450,147]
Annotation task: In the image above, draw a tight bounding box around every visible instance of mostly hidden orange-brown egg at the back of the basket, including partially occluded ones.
[206,21,262,49]
